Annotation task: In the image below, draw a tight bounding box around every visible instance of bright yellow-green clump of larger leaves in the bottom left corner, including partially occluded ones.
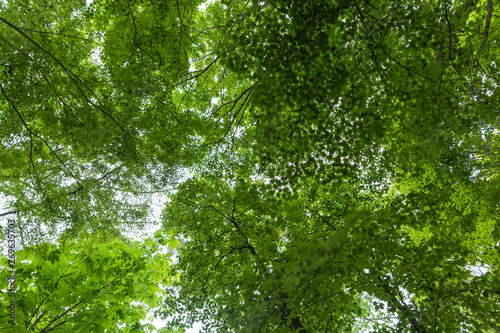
[0,232,171,333]
